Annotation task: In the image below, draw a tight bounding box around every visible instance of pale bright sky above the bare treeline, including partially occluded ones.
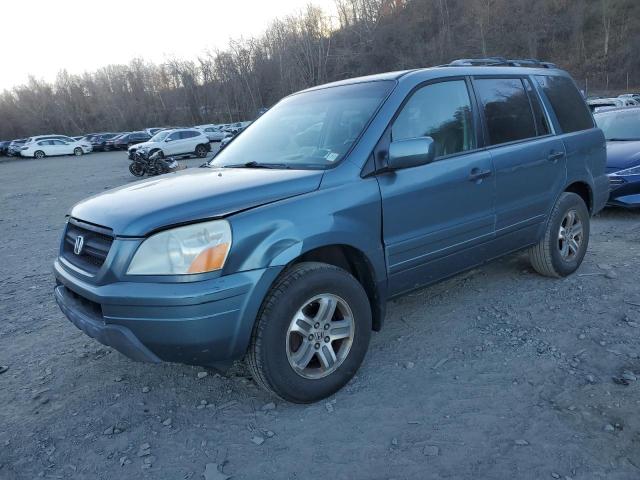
[0,0,335,90]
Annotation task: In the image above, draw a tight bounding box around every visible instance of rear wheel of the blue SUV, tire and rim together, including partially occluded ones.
[529,192,590,278]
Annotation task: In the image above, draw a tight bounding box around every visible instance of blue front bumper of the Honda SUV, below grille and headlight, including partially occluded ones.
[54,260,281,365]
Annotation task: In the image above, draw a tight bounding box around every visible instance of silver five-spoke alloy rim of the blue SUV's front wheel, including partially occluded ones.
[286,293,355,379]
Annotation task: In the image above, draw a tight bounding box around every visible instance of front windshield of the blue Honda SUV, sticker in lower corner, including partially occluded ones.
[210,81,394,168]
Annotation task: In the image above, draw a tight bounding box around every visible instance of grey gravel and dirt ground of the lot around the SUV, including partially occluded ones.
[0,153,640,480]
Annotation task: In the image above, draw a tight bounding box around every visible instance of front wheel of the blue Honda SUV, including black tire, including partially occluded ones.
[246,262,372,403]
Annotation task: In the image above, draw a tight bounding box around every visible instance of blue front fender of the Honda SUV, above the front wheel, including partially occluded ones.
[225,174,386,284]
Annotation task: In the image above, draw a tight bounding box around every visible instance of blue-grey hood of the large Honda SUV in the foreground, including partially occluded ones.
[71,168,323,237]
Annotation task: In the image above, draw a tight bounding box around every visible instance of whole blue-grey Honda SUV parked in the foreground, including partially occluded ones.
[54,59,609,403]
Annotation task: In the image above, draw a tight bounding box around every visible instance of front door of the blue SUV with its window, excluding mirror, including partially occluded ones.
[378,78,495,295]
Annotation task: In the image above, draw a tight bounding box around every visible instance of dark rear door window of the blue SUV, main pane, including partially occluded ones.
[474,78,536,145]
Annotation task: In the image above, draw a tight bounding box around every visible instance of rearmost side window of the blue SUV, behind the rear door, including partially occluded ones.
[536,75,593,133]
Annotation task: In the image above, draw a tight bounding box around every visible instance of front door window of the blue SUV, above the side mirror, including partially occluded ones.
[391,80,476,157]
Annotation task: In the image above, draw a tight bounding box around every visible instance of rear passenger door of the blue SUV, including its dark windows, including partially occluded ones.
[473,77,566,242]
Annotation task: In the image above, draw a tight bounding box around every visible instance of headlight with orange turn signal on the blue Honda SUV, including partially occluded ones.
[127,220,231,275]
